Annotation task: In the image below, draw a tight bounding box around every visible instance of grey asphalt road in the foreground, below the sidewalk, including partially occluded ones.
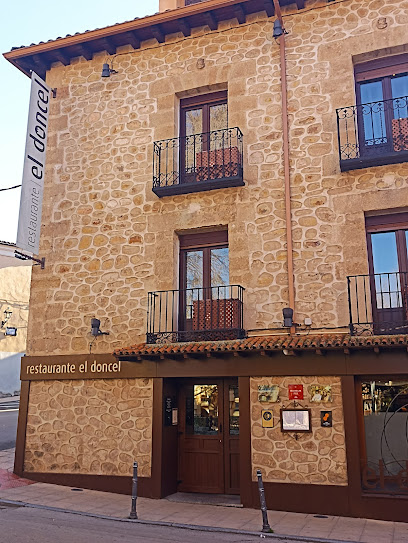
[0,503,316,543]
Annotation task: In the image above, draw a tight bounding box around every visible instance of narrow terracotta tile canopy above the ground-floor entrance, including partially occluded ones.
[114,334,408,358]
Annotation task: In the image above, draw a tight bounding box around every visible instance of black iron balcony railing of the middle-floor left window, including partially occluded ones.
[146,285,245,343]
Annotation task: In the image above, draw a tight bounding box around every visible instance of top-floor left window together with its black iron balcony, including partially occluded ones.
[153,91,244,197]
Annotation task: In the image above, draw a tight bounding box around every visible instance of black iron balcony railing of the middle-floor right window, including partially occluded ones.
[347,272,408,335]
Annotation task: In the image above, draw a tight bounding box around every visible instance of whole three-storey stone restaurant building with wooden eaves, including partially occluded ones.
[5,0,408,521]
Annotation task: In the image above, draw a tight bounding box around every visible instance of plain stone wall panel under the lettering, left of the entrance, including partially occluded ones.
[24,379,153,477]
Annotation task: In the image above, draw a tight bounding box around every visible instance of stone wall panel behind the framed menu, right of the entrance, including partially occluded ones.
[251,377,347,485]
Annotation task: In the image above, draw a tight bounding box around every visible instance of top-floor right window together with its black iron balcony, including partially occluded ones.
[337,55,408,171]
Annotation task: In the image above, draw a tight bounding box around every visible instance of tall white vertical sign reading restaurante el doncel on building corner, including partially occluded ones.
[16,72,51,255]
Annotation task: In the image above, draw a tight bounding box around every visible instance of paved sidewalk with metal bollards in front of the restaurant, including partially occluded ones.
[0,449,408,543]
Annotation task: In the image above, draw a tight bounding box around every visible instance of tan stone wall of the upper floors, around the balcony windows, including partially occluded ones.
[28,0,408,354]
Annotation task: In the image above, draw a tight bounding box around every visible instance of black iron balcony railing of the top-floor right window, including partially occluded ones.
[337,96,408,172]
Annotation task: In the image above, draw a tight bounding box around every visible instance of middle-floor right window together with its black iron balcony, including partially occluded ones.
[348,213,408,335]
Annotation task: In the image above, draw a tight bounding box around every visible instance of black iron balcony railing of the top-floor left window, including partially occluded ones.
[153,128,244,198]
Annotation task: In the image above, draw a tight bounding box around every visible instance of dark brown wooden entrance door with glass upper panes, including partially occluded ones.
[178,379,239,494]
